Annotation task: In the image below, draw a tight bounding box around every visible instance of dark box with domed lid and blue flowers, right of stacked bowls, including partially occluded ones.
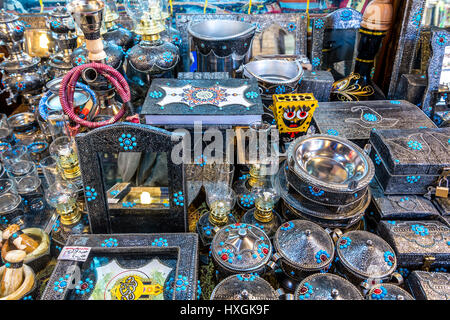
[370,128,450,195]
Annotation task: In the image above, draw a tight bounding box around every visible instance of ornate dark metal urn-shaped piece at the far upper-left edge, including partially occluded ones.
[0,10,44,111]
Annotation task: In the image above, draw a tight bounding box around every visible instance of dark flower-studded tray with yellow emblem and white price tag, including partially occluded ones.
[42,233,198,300]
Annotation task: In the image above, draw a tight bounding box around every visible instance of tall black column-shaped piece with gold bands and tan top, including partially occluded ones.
[331,0,393,101]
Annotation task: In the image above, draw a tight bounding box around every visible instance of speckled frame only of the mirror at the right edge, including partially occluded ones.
[422,27,450,115]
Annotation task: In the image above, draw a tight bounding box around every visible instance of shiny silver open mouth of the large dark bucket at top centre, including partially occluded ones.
[188,20,256,41]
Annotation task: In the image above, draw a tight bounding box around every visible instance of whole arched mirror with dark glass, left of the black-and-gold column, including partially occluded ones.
[311,8,362,81]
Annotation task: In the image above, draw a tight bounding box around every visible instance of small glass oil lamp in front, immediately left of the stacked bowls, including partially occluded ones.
[241,183,281,238]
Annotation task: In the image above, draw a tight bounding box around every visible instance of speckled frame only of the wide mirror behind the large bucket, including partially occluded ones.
[175,13,307,71]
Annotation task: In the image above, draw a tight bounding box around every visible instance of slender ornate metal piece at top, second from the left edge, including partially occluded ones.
[47,5,77,79]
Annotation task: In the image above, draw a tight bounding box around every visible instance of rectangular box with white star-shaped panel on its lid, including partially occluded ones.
[141,79,264,126]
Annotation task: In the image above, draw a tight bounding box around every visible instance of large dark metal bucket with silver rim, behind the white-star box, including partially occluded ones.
[188,20,256,72]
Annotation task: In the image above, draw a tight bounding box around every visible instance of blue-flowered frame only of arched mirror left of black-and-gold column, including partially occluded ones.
[311,8,362,70]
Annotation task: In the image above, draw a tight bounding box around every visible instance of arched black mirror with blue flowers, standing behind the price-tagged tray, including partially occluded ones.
[75,123,188,233]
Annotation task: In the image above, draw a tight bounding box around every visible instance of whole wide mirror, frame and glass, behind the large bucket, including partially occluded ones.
[176,13,307,71]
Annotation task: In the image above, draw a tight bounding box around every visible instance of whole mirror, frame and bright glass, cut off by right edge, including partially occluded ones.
[422,27,450,114]
